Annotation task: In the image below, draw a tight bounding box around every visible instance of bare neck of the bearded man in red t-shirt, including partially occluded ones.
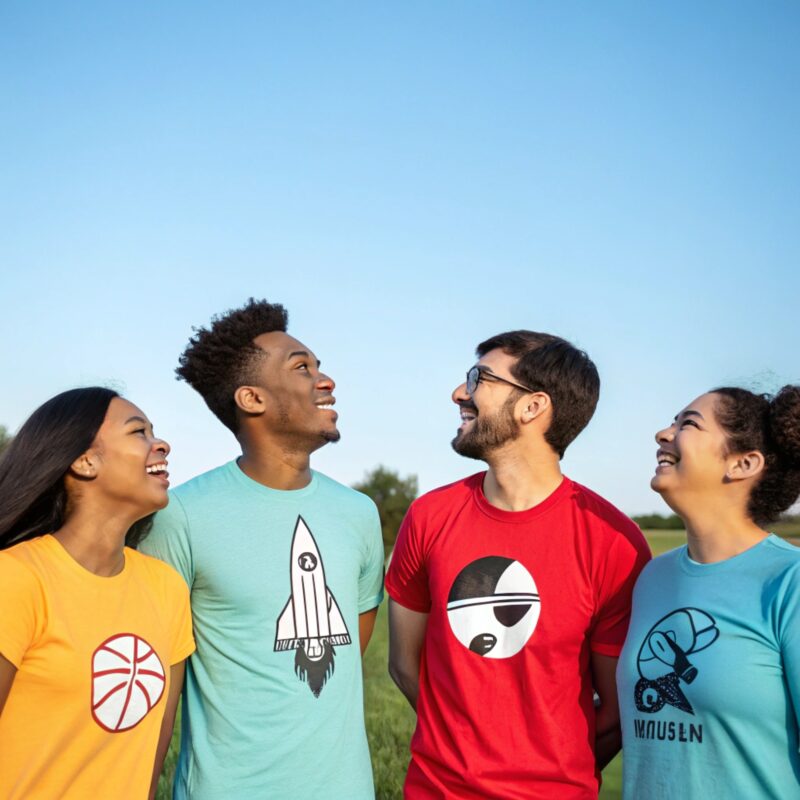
[483,443,564,511]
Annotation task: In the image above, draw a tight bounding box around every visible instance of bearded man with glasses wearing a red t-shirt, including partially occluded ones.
[386,331,650,800]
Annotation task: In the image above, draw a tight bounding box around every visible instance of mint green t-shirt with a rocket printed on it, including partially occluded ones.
[141,461,383,800]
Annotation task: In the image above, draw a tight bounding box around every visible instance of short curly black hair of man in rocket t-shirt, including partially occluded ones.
[175,297,289,434]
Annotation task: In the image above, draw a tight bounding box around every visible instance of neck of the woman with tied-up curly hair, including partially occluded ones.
[679,501,768,564]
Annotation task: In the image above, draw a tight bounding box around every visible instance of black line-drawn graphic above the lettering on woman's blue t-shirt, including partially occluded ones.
[633,608,719,714]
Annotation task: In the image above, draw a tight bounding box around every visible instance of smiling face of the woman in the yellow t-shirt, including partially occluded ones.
[85,397,169,519]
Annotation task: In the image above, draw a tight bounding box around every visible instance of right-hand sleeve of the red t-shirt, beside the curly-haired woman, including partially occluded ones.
[589,522,651,658]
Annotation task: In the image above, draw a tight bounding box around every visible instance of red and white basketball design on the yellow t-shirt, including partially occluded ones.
[92,633,166,733]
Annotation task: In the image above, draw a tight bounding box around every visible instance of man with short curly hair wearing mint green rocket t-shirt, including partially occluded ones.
[141,300,383,800]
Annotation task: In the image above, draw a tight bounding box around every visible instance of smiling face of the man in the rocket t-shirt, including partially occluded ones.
[248,331,340,453]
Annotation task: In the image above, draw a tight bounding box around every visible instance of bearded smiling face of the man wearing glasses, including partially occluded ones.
[451,349,520,460]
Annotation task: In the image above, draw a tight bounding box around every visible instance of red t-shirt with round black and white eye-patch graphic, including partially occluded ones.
[386,472,650,800]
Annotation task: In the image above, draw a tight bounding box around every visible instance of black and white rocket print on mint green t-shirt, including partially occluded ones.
[275,517,351,697]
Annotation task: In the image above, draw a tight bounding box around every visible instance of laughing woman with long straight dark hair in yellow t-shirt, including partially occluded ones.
[0,387,194,800]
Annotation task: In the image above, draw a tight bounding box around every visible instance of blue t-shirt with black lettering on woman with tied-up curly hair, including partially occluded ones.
[617,535,800,800]
